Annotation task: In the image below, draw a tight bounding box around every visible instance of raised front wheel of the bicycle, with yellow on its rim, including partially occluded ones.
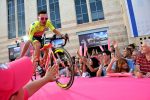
[54,48,74,89]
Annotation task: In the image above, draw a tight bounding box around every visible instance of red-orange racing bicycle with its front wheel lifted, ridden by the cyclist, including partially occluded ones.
[32,34,74,89]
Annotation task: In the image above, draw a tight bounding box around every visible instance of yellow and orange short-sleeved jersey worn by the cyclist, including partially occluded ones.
[29,20,55,41]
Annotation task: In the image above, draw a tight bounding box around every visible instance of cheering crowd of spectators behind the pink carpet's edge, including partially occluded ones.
[73,40,150,78]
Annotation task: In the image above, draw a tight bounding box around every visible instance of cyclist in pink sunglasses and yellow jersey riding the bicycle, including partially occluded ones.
[20,11,61,62]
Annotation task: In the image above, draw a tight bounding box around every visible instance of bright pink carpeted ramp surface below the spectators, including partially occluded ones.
[29,77,150,100]
